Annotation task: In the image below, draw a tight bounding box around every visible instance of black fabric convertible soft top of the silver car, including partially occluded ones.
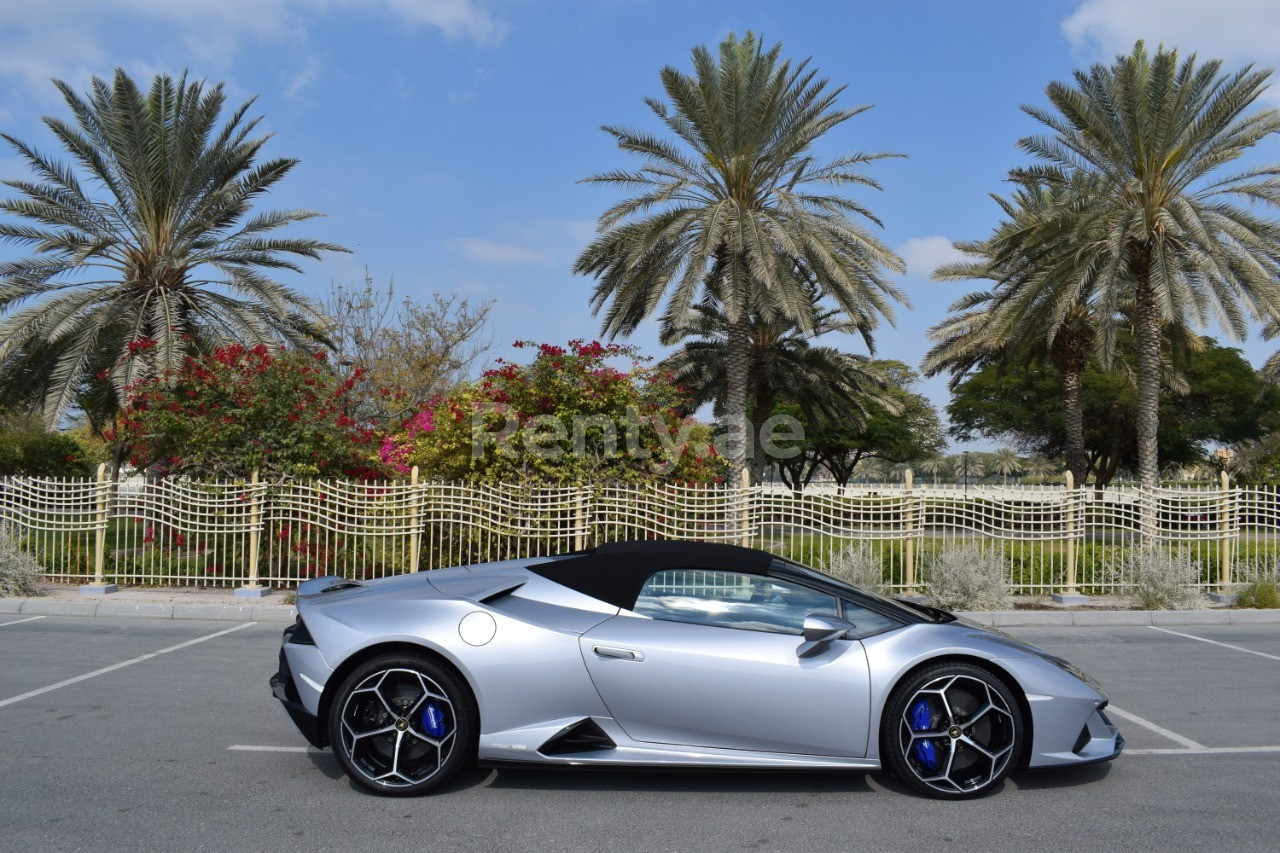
[529,540,773,610]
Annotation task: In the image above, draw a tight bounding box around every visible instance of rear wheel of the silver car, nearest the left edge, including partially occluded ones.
[329,653,480,797]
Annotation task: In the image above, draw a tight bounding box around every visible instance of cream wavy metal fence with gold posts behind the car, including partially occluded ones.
[0,471,1280,593]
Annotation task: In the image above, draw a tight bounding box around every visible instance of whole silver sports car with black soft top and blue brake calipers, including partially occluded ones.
[271,542,1124,799]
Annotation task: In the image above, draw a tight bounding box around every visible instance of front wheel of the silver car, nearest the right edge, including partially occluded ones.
[881,662,1025,799]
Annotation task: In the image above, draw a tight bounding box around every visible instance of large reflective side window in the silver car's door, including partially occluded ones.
[635,569,836,635]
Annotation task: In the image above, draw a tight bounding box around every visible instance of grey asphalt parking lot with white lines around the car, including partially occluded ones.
[0,615,1280,852]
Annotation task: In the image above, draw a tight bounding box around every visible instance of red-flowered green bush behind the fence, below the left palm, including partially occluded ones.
[120,345,384,482]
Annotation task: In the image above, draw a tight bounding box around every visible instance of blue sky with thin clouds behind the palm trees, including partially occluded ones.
[0,0,1280,450]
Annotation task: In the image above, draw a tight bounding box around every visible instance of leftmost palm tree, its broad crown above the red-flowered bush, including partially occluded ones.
[0,69,346,425]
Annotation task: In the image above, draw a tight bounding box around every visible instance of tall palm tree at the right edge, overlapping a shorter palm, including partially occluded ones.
[1011,41,1280,487]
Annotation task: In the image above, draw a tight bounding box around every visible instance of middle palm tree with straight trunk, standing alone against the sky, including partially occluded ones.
[573,33,905,479]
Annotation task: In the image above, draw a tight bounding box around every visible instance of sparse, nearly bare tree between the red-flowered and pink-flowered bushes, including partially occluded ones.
[324,273,493,425]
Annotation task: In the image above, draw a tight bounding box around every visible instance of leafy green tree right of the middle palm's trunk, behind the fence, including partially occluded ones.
[777,360,946,488]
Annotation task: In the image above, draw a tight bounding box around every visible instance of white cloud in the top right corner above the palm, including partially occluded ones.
[1062,0,1280,67]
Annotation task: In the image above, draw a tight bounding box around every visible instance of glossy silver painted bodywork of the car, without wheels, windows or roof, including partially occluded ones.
[284,560,1116,770]
